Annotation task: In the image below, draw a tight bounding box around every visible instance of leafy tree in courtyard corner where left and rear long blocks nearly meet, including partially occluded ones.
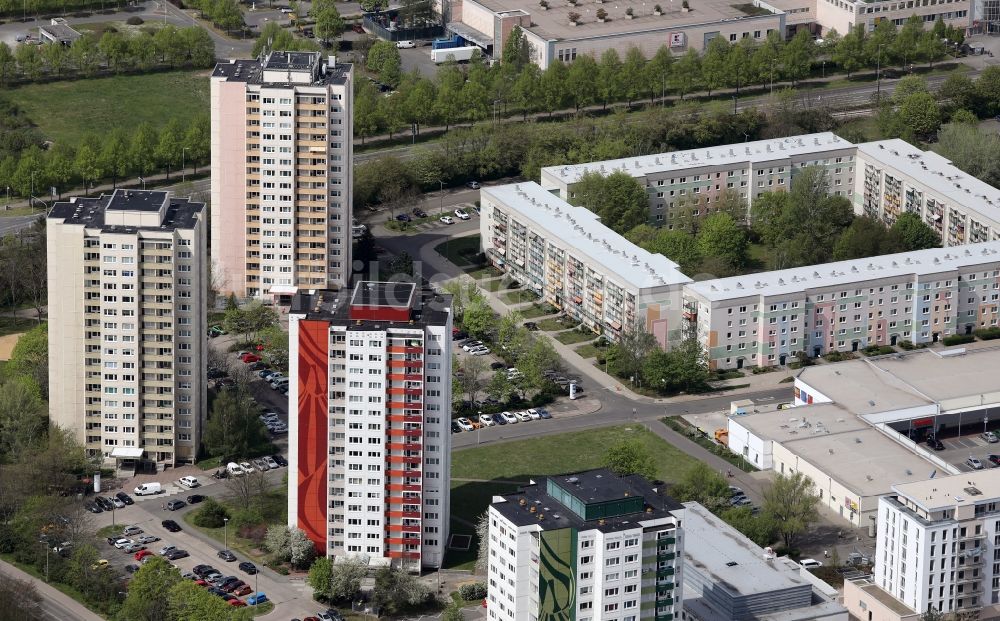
[573,170,649,233]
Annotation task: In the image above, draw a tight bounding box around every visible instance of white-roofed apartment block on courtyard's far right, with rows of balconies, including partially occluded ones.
[854,139,1000,246]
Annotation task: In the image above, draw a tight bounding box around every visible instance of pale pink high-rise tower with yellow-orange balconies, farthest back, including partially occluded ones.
[211,52,354,301]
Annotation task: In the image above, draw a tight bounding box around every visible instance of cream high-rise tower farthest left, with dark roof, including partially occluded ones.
[47,190,208,466]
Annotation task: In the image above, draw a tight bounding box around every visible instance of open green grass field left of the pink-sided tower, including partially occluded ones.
[0,70,208,144]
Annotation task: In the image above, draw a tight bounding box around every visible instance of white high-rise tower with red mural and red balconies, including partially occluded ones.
[288,281,452,571]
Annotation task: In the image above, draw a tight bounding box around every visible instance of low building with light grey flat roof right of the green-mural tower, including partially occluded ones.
[683,502,848,621]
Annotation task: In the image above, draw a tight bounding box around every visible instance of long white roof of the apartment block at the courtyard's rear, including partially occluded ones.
[542,132,854,184]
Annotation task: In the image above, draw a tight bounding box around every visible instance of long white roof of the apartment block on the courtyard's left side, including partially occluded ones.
[481,182,691,289]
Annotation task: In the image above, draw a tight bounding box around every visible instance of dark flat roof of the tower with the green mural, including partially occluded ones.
[490,468,683,533]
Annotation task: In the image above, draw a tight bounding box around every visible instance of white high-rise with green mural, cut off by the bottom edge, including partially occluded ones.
[486,469,684,621]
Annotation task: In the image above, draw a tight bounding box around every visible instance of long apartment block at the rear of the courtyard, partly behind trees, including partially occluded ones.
[541,132,857,229]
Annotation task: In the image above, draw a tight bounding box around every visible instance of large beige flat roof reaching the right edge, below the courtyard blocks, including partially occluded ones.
[798,347,1000,415]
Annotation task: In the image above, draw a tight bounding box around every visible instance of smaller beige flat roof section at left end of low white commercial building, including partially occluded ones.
[729,403,869,444]
